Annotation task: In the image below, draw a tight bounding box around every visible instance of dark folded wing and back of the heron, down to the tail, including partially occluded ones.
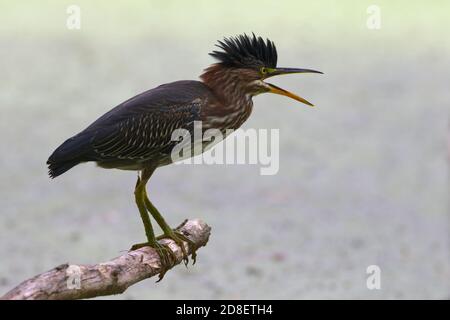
[47,81,213,177]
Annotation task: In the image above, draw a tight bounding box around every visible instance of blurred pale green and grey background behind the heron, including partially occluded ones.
[0,0,450,299]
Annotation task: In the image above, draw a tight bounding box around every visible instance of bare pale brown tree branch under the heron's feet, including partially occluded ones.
[0,220,211,300]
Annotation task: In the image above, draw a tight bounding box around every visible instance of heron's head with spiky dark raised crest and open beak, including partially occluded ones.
[202,34,322,106]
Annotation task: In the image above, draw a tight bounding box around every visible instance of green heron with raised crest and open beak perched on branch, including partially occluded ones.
[47,34,321,276]
